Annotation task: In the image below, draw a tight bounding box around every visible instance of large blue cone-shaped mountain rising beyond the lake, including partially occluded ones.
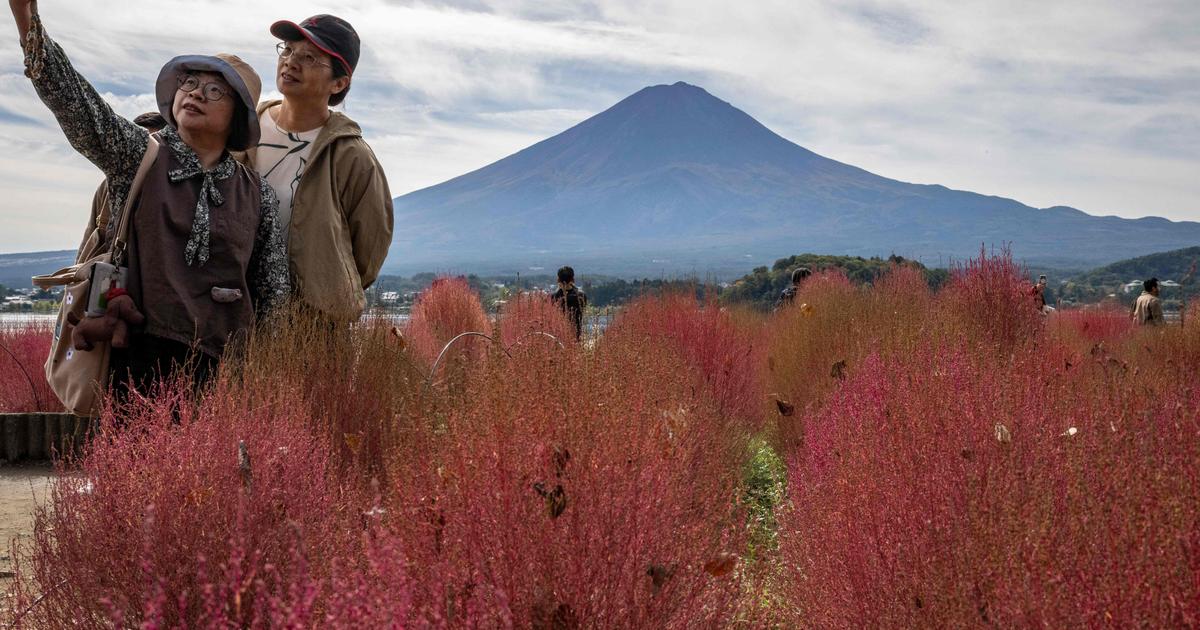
[385,83,1200,274]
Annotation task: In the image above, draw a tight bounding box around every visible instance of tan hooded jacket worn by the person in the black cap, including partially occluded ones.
[236,101,392,320]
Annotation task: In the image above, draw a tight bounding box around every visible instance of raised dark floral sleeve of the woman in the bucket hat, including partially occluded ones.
[24,13,149,209]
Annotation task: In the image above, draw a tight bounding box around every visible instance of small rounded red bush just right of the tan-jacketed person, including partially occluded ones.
[406,277,492,365]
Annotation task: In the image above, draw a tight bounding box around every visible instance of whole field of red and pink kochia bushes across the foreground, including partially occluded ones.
[0,254,1200,629]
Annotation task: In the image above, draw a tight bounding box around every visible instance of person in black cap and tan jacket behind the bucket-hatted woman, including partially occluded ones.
[237,16,392,322]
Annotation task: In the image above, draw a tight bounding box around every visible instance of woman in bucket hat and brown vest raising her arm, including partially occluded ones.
[8,0,289,390]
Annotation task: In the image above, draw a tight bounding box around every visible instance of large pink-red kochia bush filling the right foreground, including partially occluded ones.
[781,346,1200,628]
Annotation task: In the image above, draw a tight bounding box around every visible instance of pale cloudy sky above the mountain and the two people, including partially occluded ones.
[0,0,1200,252]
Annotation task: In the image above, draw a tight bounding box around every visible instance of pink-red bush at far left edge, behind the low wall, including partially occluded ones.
[0,324,62,413]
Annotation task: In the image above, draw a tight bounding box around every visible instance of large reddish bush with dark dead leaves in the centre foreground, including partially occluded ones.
[379,336,744,628]
